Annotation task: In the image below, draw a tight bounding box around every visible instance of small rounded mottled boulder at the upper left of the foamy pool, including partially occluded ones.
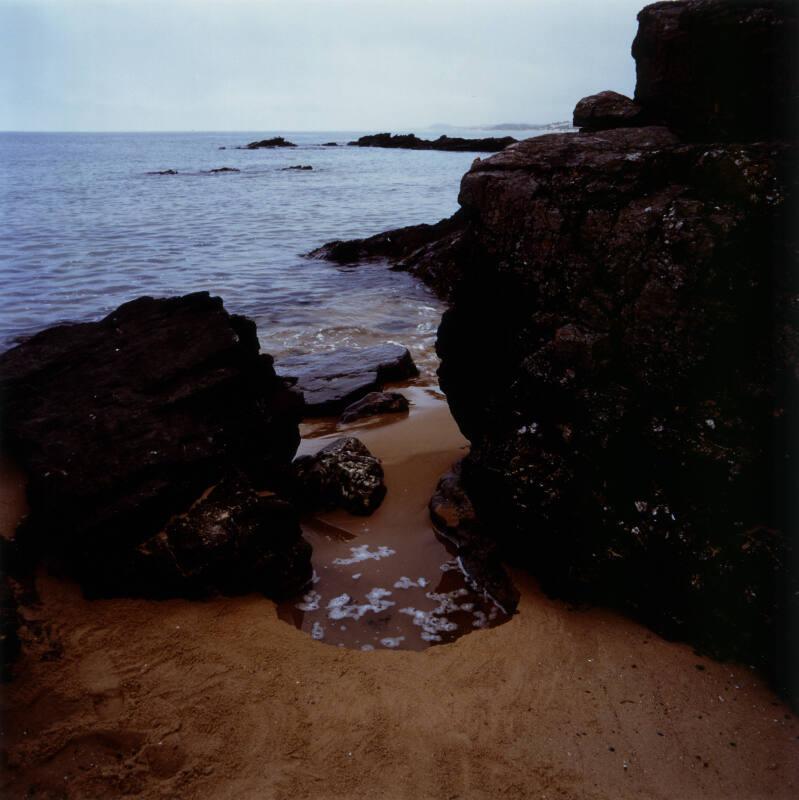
[294,436,386,515]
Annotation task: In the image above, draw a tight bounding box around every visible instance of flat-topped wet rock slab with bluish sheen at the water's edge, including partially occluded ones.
[277,344,418,417]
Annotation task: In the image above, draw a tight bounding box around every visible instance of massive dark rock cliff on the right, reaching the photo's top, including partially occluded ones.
[310,0,799,689]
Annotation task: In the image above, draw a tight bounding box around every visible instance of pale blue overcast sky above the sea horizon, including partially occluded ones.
[0,0,645,131]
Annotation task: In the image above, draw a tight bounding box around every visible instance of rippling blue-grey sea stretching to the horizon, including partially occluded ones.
[0,130,552,369]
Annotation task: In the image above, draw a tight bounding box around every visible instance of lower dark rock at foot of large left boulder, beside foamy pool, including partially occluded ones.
[108,476,312,599]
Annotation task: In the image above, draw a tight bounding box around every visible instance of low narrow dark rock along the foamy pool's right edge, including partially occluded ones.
[430,462,519,614]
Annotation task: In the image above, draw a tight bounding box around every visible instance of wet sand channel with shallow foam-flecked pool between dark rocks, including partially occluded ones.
[279,385,507,650]
